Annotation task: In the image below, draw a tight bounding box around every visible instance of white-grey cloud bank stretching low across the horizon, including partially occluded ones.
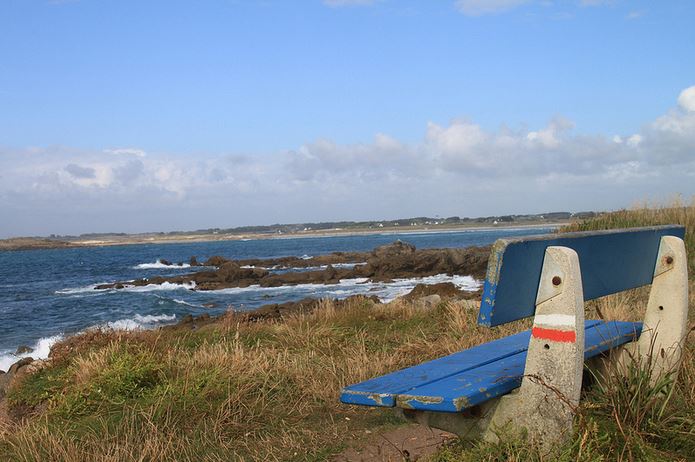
[0,86,695,237]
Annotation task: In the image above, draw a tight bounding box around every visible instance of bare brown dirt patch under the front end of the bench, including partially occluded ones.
[331,424,456,462]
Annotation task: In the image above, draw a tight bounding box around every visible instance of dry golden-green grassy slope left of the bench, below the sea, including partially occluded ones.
[0,298,532,461]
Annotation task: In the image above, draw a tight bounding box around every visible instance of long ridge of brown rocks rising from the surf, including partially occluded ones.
[97,241,489,290]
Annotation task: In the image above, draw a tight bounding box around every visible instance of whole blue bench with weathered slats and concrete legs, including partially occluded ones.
[340,226,688,444]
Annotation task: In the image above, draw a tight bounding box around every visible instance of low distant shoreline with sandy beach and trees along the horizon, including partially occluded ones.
[0,220,570,251]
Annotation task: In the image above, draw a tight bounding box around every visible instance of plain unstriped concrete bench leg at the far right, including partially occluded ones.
[620,236,688,383]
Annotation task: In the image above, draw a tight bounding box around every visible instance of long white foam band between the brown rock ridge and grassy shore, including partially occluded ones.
[211,274,481,303]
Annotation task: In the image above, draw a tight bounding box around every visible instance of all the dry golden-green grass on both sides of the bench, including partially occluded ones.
[0,205,695,462]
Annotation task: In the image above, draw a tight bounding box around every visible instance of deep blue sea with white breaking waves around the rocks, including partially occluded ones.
[0,227,553,371]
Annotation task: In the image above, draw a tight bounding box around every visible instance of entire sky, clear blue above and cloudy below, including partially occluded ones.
[0,0,695,237]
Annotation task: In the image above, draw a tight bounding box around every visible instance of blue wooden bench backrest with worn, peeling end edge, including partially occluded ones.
[478,226,685,326]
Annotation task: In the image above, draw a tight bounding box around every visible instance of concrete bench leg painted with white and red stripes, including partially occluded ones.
[483,247,584,447]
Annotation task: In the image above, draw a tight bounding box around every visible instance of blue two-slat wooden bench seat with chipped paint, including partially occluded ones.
[340,320,642,412]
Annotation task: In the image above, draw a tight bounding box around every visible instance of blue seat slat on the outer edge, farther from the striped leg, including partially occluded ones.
[340,320,601,407]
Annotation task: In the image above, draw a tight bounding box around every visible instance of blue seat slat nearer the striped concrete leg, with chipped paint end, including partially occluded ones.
[396,321,642,412]
